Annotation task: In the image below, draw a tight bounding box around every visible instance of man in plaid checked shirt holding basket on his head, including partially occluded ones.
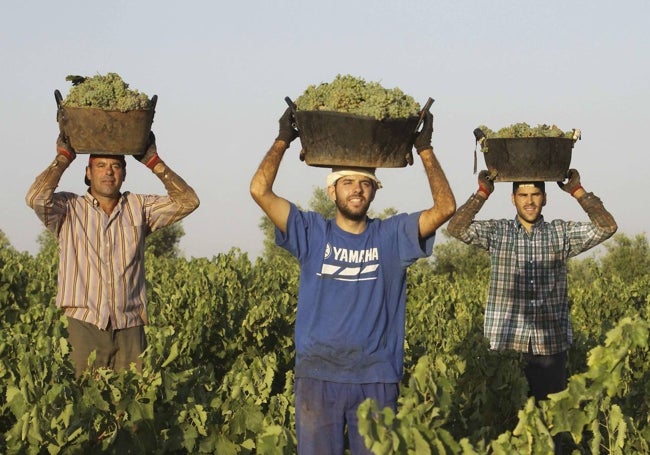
[448,169,617,400]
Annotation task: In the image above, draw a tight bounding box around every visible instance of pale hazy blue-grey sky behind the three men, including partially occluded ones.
[0,0,650,257]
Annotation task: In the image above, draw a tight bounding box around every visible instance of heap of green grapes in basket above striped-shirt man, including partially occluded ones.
[62,73,152,112]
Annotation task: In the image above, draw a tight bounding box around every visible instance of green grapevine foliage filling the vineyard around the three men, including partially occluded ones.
[0,232,650,455]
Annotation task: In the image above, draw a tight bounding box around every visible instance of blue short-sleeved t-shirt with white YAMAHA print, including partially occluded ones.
[275,204,435,384]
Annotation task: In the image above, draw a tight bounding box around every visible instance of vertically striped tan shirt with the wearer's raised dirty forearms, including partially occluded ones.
[26,157,199,329]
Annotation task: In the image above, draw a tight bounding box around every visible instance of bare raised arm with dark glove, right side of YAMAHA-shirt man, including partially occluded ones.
[414,112,456,238]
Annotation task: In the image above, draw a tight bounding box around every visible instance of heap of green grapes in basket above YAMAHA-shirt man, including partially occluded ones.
[295,74,420,120]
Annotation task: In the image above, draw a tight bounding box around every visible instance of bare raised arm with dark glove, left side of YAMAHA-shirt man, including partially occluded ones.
[250,108,298,232]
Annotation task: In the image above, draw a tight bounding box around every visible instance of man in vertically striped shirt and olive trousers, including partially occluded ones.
[26,133,199,376]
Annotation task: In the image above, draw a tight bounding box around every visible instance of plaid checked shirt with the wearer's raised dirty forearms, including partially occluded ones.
[448,193,616,355]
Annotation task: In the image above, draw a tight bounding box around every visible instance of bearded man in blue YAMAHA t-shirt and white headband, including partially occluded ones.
[250,109,456,455]
